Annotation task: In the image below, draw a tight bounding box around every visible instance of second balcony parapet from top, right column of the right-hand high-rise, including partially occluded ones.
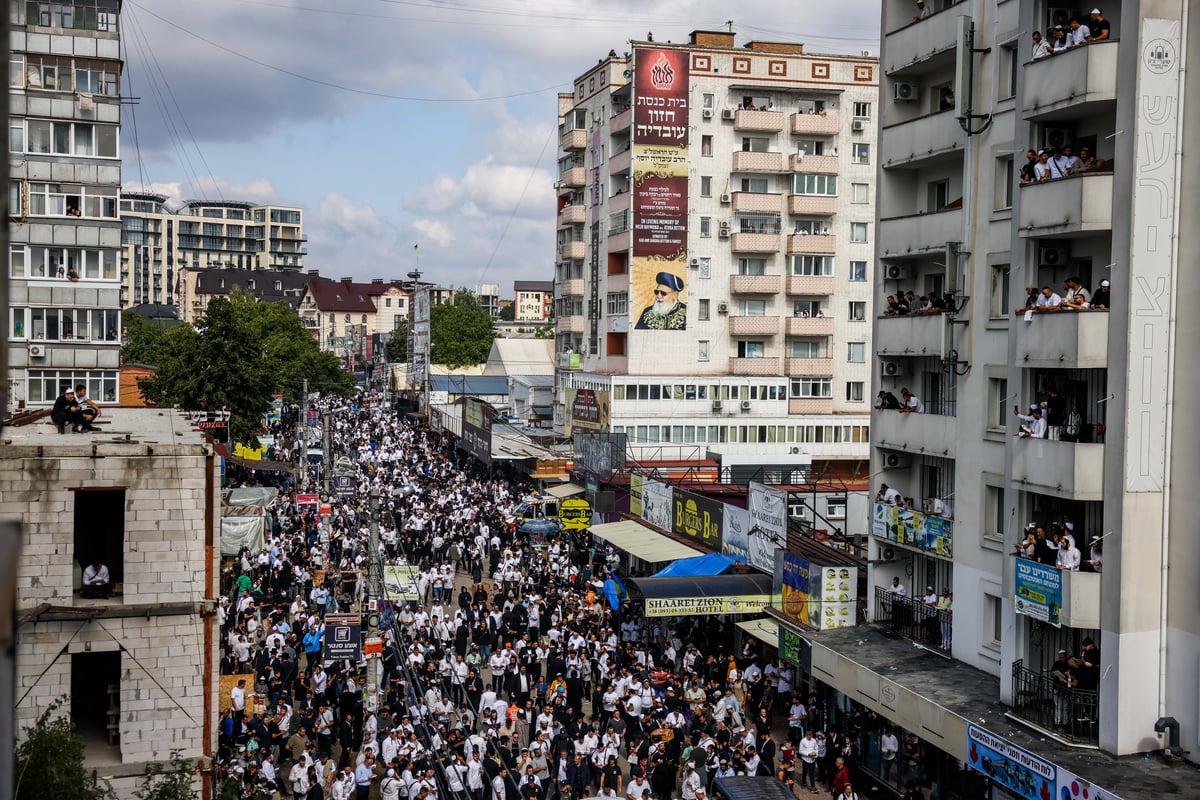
[1019,173,1112,237]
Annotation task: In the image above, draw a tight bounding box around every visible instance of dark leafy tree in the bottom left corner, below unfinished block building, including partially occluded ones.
[13,697,113,800]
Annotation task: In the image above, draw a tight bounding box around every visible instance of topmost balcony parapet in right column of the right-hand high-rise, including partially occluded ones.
[1021,41,1120,122]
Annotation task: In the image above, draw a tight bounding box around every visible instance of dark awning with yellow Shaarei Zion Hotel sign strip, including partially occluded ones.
[633,575,770,616]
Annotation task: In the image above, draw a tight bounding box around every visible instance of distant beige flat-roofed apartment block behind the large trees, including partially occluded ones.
[120,192,308,311]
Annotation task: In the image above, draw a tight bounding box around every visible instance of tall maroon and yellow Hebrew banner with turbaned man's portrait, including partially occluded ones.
[629,47,689,331]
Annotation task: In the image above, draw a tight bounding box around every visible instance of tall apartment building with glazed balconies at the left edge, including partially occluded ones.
[6,0,121,405]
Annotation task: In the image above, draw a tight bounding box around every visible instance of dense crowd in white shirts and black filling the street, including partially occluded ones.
[213,399,923,800]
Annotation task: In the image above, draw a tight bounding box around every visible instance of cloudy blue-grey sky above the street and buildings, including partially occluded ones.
[121,0,880,296]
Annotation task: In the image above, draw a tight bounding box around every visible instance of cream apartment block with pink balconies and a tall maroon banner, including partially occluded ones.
[554,31,878,474]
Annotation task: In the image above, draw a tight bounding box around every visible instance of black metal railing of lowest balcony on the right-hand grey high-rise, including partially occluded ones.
[1009,658,1100,746]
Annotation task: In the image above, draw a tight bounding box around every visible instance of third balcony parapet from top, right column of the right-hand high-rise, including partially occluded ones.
[1016,311,1109,369]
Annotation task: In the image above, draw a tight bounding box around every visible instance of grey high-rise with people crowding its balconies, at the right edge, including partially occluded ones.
[854,0,1200,782]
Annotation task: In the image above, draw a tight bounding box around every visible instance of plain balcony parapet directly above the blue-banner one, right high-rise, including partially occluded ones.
[1012,439,1104,501]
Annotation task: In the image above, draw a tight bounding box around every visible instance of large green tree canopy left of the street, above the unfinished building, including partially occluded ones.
[121,293,354,443]
